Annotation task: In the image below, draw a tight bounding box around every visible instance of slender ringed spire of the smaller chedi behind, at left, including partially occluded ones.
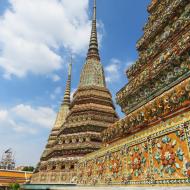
[62,56,72,106]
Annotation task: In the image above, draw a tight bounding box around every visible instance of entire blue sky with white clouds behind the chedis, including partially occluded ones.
[0,0,150,165]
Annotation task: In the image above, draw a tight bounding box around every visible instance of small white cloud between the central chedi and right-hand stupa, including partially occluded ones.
[105,59,121,83]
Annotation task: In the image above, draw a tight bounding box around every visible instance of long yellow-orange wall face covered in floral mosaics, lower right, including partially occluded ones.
[77,111,190,186]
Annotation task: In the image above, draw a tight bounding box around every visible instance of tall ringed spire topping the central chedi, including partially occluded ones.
[87,0,100,60]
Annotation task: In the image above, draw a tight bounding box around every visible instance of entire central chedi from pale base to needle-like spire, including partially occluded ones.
[32,0,118,183]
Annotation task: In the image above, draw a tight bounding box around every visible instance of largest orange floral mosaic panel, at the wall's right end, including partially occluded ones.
[153,129,189,178]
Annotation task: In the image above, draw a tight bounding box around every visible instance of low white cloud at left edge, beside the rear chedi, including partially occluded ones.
[0,104,56,134]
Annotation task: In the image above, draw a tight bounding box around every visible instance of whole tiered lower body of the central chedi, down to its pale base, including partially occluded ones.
[32,86,118,183]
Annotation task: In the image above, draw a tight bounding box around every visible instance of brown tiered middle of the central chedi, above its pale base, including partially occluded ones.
[42,86,118,161]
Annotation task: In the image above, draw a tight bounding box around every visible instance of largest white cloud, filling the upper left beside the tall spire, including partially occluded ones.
[0,0,90,78]
